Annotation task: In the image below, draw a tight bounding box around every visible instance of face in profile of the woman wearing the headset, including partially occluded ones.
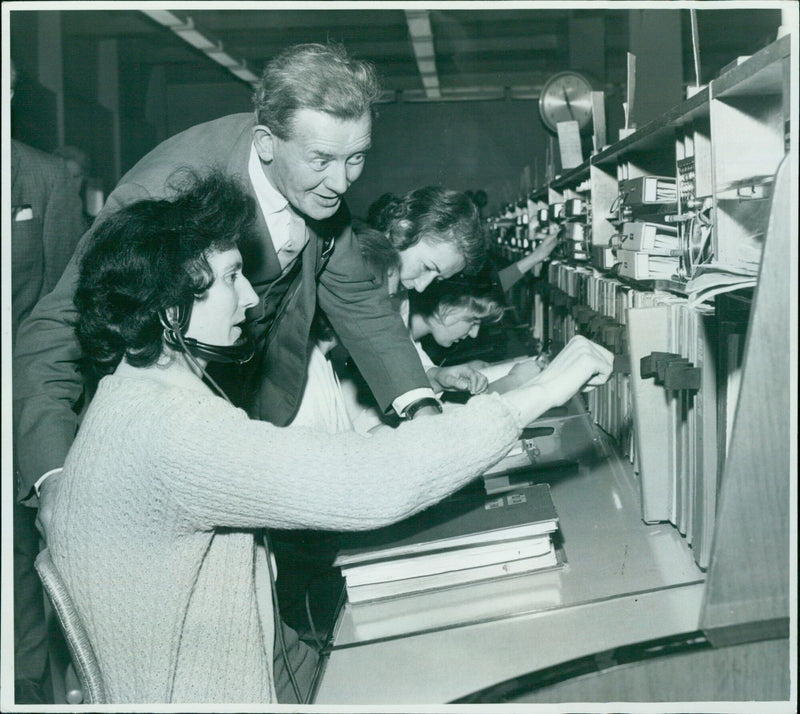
[186,248,258,347]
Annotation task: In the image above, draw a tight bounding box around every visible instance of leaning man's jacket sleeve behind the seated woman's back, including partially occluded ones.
[13,181,152,506]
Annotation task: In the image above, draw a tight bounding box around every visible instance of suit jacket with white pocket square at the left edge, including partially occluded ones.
[11,139,84,344]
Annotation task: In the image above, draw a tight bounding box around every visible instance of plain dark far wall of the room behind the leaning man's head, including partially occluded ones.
[158,84,568,215]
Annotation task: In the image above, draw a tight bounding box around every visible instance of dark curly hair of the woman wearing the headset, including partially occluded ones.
[75,172,255,379]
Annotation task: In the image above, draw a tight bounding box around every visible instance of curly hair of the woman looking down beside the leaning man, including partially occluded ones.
[367,186,488,275]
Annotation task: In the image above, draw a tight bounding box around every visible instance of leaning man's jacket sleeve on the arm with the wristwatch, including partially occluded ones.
[317,222,430,411]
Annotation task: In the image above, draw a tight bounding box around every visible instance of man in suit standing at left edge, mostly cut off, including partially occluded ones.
[10,62,83,704]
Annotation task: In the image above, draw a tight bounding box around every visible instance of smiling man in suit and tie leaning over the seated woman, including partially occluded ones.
[14,45,446,701]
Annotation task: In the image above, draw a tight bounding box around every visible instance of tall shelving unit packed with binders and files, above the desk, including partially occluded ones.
[482,30,797,688]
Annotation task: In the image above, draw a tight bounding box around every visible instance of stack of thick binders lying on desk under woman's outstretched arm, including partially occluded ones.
[334,484,559,605]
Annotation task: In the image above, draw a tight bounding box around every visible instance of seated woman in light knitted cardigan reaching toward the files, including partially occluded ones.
[48,171,611,703]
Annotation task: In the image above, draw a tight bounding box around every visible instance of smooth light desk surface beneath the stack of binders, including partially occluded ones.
[315,434,704,704]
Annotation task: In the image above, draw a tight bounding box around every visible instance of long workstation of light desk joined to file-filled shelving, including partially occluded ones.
[316,32,797,704]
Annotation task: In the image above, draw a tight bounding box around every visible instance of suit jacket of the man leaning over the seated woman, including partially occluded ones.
[14,114,429,495]
